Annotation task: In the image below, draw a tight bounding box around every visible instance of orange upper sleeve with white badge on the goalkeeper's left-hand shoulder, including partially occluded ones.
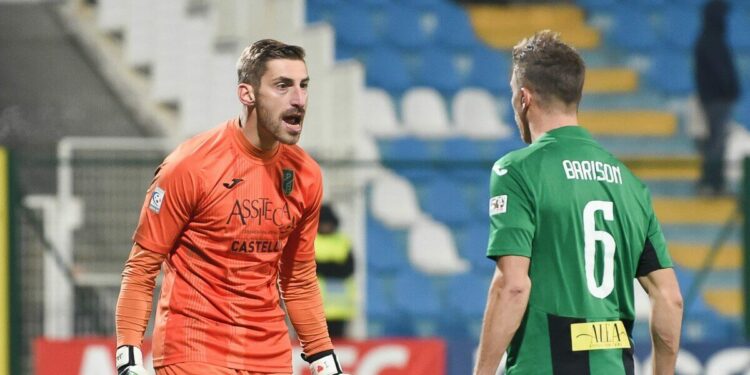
[133,154,201,254]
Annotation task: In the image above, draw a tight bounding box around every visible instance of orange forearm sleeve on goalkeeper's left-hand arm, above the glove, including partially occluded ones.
[115,244,166,346]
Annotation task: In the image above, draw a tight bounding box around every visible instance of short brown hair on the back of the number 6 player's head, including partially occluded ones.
[513,30,586,106]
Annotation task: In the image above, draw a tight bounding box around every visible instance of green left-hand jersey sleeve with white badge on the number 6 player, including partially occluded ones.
[487,159,536,260]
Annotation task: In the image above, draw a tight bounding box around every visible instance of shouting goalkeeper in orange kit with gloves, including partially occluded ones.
[116,39,350,375]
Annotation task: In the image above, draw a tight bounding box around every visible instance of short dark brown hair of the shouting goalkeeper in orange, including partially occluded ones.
[237,39,305,86]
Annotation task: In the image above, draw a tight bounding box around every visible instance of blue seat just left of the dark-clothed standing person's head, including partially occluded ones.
[659,5,701,51]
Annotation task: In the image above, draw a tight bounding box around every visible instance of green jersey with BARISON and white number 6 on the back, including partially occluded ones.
[487,126,672,374]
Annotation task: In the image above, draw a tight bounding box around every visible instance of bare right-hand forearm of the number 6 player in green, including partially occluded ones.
[638,268,682,374]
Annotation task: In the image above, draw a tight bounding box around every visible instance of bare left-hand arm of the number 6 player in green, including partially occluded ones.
[474,255,531,375]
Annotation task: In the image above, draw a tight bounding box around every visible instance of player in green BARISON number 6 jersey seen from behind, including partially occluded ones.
[475,30,682,375]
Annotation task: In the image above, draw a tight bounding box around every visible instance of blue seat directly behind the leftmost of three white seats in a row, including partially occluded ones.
[366,46,412,96]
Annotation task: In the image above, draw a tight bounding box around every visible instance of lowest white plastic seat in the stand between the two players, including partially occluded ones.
[408,217,469,275]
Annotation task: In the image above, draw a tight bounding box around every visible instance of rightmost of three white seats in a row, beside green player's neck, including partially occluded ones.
[452,88,511,139]
